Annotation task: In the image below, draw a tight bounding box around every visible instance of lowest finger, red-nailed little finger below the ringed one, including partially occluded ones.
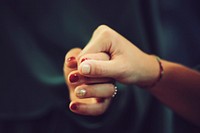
[69,99,111,116]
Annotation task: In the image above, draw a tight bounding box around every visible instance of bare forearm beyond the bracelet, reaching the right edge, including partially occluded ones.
[150,61,200,127]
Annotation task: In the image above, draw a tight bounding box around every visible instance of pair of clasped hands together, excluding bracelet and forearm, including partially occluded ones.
[63,25,159,116]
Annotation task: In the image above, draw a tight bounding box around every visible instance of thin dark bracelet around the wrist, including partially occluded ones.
[147,55,164,88]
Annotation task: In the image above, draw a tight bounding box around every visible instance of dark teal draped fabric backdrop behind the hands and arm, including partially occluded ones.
[0,0,200,133]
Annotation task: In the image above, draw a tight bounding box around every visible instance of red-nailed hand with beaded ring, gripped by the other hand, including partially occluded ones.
[63,48,114,115]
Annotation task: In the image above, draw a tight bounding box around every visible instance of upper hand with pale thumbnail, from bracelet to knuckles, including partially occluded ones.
[78,25,159,86]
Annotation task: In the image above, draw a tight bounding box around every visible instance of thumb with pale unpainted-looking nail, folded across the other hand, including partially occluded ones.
[78,60,119,78]
